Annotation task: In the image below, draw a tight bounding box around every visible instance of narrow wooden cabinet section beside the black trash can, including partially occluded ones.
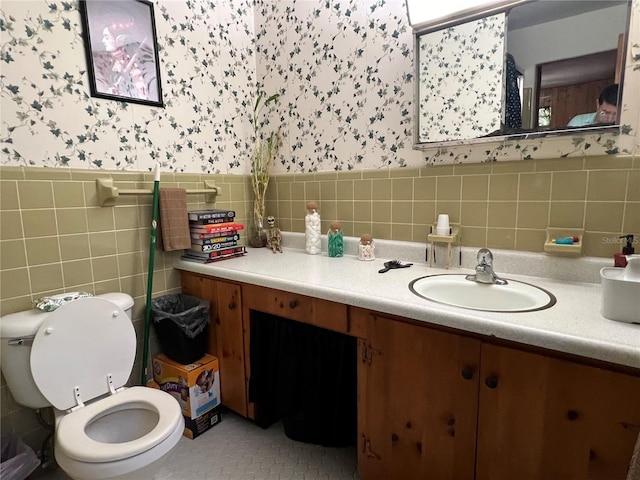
[180,272,247,417]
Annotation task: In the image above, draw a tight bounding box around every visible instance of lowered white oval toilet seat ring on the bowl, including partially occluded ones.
[56,387,182,463]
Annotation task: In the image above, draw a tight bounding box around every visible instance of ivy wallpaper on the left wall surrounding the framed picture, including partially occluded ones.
[0,0,256,173]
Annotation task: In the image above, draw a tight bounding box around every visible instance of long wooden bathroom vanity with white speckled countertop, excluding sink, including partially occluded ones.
[175,242,640,480]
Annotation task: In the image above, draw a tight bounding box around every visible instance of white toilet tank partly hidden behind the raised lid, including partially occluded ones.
[0,292,133,408]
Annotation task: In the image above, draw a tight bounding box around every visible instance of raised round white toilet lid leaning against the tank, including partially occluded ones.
[31,297,136,410]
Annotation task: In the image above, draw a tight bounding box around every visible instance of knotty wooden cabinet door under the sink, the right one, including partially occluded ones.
[476,345,640,480]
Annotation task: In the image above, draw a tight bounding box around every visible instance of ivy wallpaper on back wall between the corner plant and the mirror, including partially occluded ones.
[255,0,421,172]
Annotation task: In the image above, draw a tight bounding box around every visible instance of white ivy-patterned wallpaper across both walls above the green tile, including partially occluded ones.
[0,0,640,175]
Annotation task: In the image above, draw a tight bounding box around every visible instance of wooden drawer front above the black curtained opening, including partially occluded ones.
[244,285,347,333]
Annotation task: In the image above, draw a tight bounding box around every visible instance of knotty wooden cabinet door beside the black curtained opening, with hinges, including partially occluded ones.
[354,309,480,480]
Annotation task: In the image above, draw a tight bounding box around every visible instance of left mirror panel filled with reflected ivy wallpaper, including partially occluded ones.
[417,13,506,142]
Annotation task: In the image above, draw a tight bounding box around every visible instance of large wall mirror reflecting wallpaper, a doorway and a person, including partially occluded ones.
[415,0,637,149]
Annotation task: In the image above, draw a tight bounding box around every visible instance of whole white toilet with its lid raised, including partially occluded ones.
[0,293,184,480]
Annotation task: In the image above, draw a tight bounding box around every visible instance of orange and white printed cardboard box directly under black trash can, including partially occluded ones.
[152,354,220,420]
